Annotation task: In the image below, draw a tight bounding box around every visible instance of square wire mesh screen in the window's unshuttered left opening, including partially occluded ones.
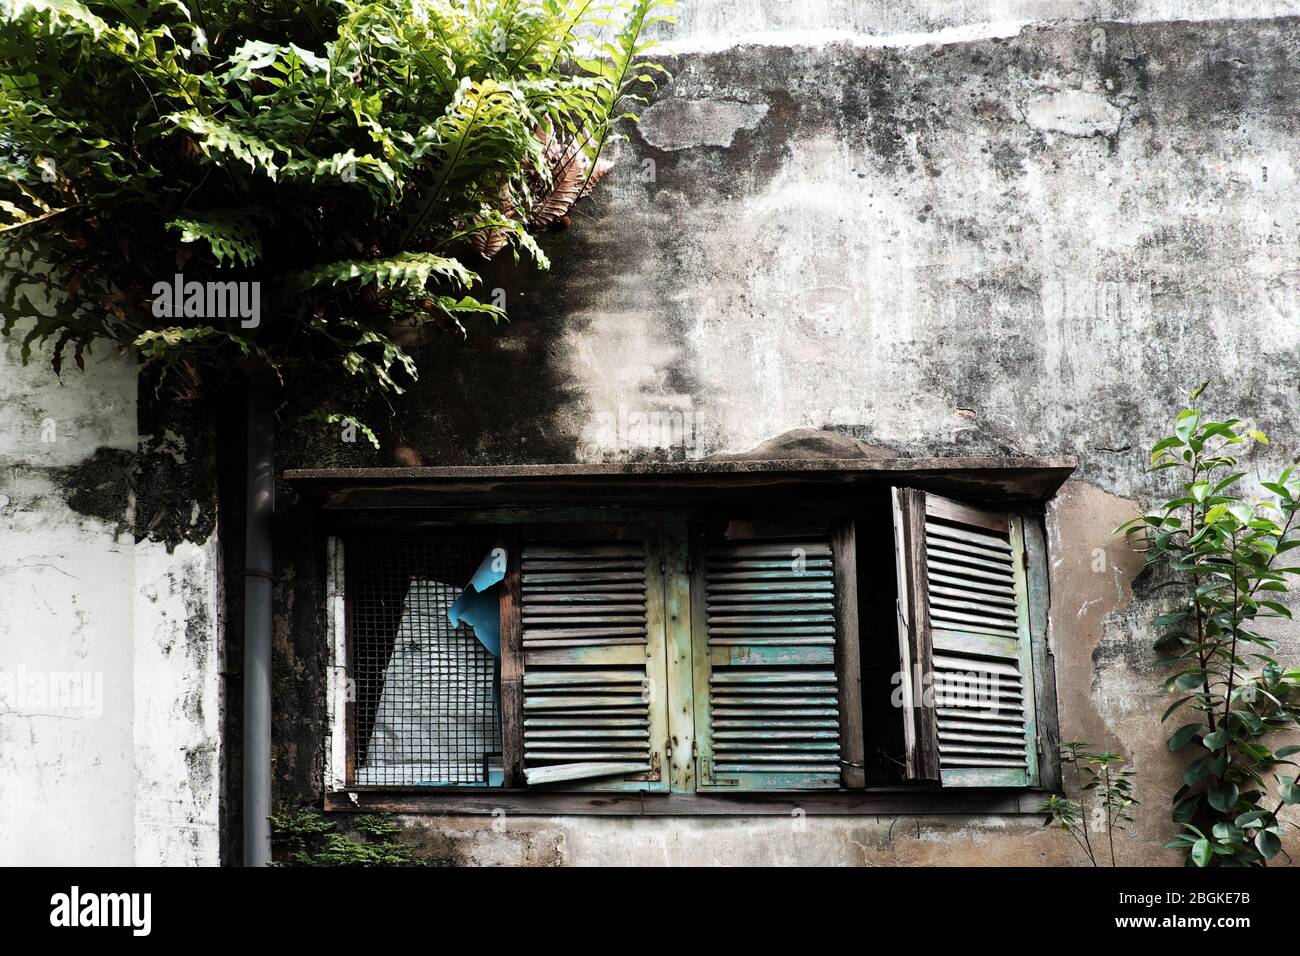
[345,531,501,787]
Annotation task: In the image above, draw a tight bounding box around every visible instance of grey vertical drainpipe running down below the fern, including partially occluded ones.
[243,382,276,866]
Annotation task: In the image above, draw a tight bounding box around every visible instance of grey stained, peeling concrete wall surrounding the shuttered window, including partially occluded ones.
[269,11,1300,865]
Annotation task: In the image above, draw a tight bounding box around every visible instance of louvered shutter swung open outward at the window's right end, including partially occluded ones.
[893,489,1039,787]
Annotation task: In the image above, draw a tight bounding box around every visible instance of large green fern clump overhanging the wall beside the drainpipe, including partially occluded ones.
[0,0,672,416]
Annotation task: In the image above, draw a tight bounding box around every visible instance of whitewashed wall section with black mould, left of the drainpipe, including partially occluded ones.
[0,327,221,865]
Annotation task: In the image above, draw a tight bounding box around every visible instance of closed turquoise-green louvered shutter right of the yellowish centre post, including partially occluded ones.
[692,523,862,790]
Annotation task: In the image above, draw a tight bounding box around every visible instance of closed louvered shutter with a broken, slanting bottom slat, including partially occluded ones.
[520,528,667,790]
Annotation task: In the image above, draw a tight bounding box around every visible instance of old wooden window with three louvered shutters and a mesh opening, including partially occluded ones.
[309,460,1058,813]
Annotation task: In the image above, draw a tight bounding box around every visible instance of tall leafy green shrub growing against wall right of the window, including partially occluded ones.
[1123,385,1300,866]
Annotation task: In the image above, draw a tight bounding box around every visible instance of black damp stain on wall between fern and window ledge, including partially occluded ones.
[277,234,599,470]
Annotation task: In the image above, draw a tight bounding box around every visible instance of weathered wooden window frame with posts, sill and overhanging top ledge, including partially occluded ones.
[306,459,1074,816]
